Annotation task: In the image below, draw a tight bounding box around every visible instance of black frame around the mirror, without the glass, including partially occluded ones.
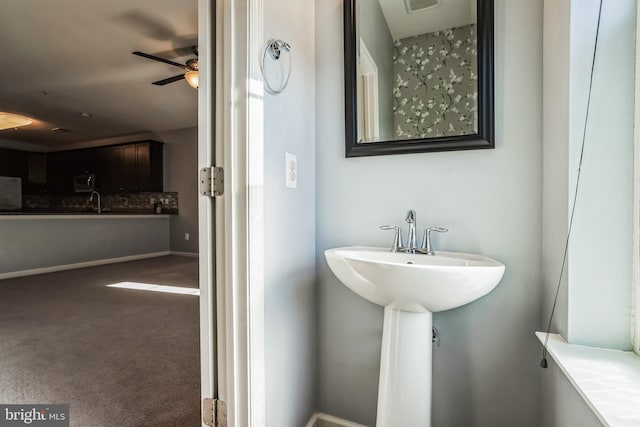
[344,0,495,157]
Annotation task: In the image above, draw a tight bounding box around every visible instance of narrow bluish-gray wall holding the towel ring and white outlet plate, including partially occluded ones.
[264,0,316,427]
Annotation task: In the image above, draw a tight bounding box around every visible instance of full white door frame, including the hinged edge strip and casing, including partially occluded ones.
[198,0,265,427]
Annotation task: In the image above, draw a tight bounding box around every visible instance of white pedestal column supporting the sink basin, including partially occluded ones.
[376,306,432,427]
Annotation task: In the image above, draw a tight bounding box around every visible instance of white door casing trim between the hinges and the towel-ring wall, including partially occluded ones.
[215,0,266,427]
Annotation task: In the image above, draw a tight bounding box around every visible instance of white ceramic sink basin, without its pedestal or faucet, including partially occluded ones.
[324,246,504,313]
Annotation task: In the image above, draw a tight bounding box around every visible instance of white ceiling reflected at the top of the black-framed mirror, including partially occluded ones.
[378,0,477,40]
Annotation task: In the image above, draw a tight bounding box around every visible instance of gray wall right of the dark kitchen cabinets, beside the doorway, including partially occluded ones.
[160,128,198,253]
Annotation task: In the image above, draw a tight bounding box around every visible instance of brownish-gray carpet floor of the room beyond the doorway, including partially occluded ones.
[0,256,200,427]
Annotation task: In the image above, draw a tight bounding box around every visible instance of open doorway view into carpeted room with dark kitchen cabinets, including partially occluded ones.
[0,0,209,426]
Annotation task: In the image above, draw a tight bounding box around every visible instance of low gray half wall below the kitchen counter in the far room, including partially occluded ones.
[0,215,169,274]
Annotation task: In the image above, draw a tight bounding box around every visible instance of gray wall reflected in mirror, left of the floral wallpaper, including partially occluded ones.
[356,0,394,140]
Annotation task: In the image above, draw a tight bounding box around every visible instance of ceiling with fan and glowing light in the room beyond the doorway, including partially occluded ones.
[0,0,198,151]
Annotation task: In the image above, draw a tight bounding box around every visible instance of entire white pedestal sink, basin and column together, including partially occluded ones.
[324,246,504,427]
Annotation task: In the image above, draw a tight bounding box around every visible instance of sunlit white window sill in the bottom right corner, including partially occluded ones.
[536,332,640,427]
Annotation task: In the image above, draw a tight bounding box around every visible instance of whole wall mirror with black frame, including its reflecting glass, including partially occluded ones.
[344,0,494,157]
